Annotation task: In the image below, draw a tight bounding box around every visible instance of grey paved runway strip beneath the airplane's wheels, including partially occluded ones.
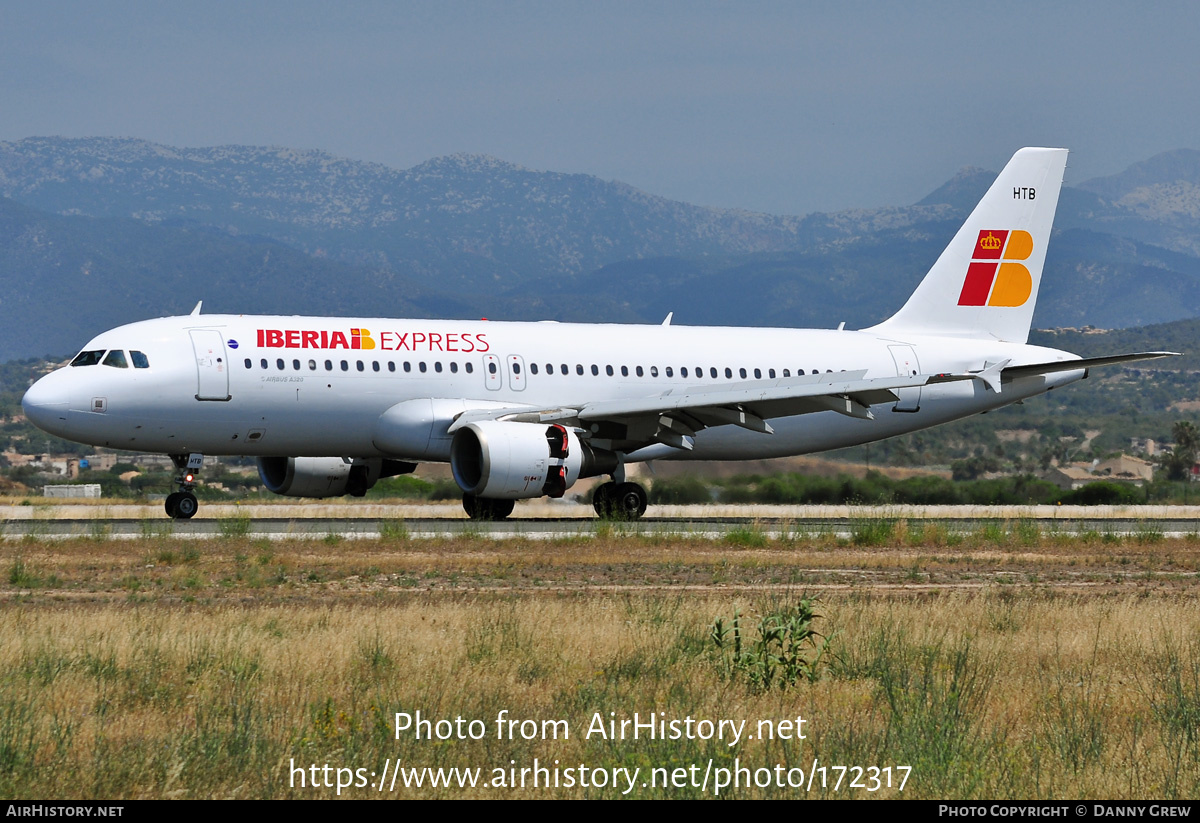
[0,503,1200,540]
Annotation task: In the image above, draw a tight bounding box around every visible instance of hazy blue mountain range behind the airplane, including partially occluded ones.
[0,138,1200,359]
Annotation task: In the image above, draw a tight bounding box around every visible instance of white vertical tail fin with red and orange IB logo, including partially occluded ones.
[869,149,1067,343]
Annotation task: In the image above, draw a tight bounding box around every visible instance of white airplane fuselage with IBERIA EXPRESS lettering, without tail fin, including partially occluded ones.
[24,314,1085,461]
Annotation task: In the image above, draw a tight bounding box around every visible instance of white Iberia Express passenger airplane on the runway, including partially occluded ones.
[22,148,1175,519]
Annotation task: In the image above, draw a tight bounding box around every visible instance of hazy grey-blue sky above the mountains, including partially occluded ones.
[0,0,1200,214]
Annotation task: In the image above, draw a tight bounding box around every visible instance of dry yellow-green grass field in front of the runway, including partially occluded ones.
[0,521,1200,799]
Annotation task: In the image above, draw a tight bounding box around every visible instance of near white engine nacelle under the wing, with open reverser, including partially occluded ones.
[450,420,617,500]
